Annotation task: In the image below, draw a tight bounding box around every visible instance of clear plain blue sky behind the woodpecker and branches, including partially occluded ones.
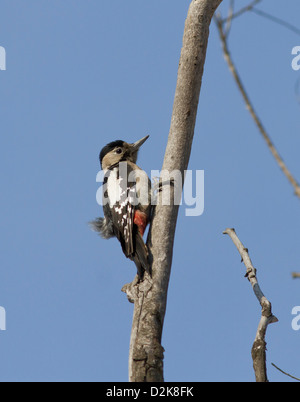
[0,0,300,381]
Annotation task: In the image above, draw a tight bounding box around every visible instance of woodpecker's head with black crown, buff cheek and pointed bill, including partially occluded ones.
[99,135,149,170]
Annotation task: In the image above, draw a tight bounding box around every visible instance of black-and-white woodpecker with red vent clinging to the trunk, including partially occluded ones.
[91,135,151,280]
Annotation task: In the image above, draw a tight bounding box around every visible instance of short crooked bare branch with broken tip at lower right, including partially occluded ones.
[223,229,278,382]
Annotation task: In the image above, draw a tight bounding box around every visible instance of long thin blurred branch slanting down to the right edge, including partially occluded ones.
[215,17,300,198]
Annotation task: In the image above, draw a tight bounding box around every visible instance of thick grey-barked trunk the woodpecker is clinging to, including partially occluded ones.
[122,0,222,382]
